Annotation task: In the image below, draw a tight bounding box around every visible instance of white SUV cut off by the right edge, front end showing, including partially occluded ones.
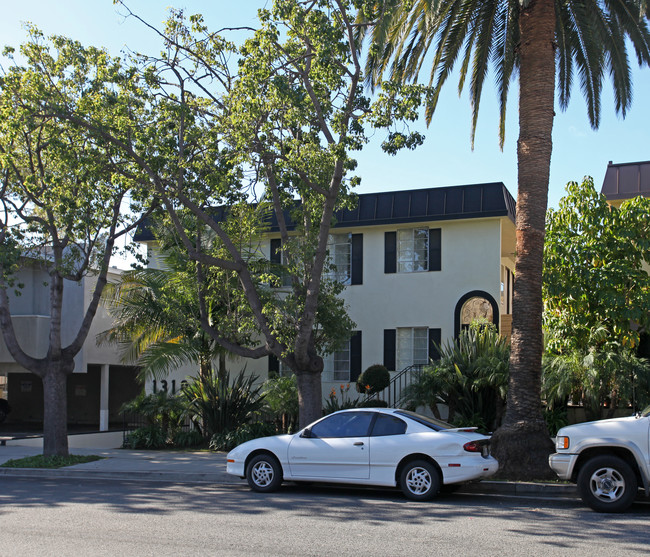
[548,406,650,512]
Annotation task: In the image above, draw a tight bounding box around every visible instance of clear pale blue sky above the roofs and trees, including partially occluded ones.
[0,0,650,264]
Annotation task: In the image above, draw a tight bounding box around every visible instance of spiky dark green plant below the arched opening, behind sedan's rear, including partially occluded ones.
[403,323,510,432]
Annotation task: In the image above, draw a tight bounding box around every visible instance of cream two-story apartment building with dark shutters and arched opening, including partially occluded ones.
[139,183,515,395]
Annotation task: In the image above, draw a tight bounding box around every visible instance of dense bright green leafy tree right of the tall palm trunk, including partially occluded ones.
[544,178,650,354]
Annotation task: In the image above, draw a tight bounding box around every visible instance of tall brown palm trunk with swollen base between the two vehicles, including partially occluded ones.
[493,0,555,480]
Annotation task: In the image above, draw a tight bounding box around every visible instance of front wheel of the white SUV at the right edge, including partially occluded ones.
[577,455,638,513]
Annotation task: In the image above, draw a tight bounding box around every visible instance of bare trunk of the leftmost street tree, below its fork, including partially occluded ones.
[42,366,68,456]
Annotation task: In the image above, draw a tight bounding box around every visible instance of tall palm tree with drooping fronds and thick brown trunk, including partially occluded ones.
[367,0,650,479]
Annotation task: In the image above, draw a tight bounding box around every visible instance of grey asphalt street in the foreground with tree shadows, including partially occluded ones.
[0,476,650,557]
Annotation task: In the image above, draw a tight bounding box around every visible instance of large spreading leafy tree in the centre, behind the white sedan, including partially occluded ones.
[27,0,422,424]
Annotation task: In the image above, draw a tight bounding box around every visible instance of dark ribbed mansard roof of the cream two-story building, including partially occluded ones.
[135,182,515,242]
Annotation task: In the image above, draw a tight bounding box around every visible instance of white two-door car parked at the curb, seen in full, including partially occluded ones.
[226,408,499,501]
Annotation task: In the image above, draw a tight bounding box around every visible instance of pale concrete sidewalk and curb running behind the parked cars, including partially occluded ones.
[0,436,577,498]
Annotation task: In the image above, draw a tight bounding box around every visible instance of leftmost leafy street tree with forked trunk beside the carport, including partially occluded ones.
[0,30,151,455]
